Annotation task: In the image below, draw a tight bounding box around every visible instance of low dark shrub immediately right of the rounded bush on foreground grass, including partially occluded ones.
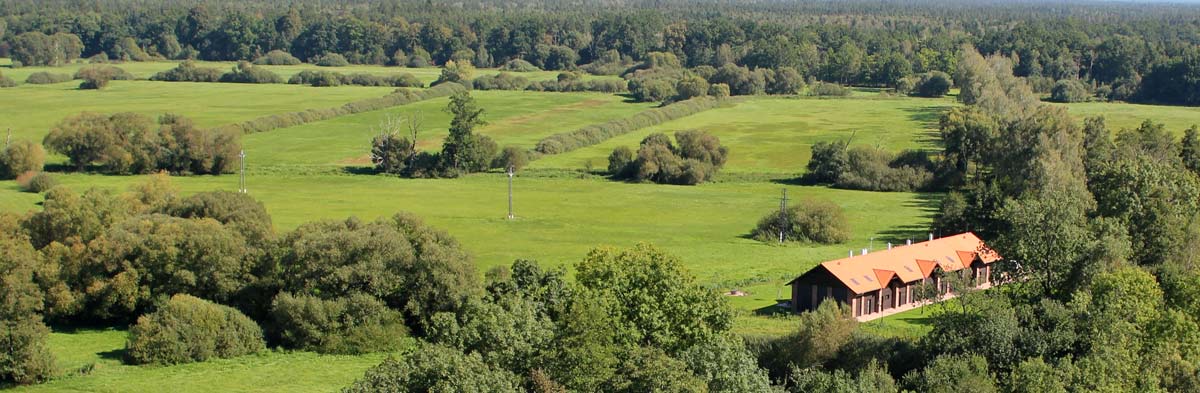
[271,292,408,355]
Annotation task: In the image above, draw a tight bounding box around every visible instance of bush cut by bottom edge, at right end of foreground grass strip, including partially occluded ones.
[343,344,523,393]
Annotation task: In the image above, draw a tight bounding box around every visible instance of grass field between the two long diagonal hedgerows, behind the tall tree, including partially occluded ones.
[242,91,650,167]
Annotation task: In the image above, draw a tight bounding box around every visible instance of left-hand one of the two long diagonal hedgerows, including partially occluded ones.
[220,83,466,133]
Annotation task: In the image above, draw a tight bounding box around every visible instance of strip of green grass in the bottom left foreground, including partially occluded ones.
[11,329,388,393]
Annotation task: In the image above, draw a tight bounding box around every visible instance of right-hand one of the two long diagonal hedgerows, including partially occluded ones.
[535,97,721,155]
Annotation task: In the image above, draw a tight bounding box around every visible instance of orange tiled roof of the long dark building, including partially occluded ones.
[821,232,1000,294]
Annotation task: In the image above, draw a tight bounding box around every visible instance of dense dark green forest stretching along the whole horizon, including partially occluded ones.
[0,0,1200,104]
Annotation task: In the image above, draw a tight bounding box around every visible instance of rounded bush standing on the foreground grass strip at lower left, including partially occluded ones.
[125,295,265,364]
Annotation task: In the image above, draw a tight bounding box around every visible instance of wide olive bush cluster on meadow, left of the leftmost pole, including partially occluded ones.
[42,113,241,175]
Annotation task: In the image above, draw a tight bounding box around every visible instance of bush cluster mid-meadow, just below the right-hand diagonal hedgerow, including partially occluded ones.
[608,131,728,185]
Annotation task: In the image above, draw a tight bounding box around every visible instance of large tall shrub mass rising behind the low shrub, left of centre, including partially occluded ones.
[278,214,478,329]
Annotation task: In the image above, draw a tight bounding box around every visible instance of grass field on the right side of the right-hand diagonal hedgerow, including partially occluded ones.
[532,92,955,174]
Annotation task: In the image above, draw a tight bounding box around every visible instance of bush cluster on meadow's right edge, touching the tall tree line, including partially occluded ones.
[805,141,937,192]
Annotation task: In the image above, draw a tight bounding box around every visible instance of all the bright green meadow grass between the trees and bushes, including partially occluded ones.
[0,58,1200,392]
